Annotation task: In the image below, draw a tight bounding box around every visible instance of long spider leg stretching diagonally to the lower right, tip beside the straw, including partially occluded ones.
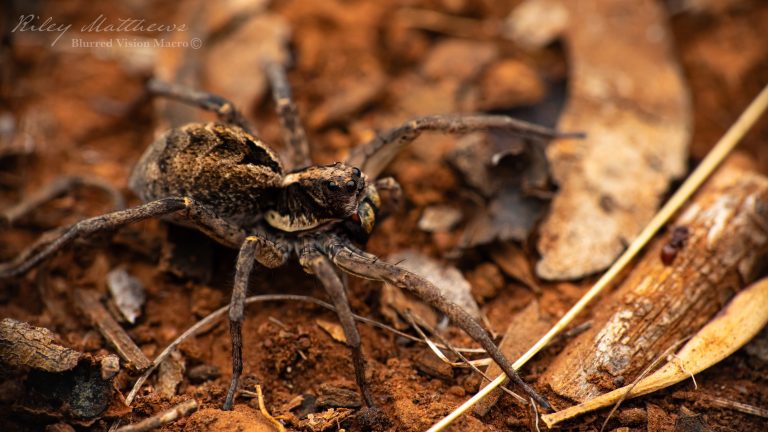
[323,237,552,410]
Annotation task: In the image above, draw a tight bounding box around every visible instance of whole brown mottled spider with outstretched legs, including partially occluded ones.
[0,63,571,410]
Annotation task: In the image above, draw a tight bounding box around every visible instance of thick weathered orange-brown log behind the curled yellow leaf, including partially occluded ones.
[544,164,768,402]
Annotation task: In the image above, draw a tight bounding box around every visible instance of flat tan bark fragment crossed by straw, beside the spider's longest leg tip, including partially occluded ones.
[473,300,551,416]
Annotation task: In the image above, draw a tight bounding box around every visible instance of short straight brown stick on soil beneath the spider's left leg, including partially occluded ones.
[74,289,152,371]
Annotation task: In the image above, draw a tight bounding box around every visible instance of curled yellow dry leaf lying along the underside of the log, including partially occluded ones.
[542,278,768,428]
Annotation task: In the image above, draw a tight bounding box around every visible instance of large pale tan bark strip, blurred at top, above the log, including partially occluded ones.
[509,0,691,280]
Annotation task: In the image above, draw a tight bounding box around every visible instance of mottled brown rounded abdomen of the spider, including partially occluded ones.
[129,123,283,226]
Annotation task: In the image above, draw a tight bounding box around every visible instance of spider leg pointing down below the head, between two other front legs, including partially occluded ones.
[299,239,375,408]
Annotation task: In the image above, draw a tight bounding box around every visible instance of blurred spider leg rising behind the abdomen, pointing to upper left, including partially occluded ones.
[147,78,256,135]
